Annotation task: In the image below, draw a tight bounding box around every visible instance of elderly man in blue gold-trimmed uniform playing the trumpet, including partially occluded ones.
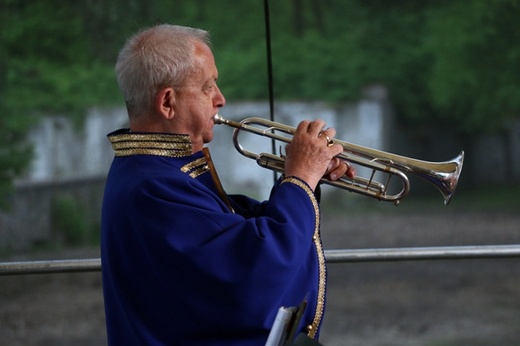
[101,25,354,346]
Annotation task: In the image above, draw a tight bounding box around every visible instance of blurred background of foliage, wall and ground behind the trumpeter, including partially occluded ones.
[0,0,520,345]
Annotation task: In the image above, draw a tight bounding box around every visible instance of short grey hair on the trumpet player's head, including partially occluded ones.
[115,24,210,119]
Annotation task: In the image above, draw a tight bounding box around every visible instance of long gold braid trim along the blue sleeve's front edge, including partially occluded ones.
[282,177,327,339]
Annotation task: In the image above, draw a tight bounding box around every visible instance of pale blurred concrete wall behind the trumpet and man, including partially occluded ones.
[18,100,392,197]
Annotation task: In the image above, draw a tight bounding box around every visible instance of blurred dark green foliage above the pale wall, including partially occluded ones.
[0,0,520,199]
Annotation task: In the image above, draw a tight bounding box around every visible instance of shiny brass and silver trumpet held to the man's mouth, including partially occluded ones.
[213,114,464,205]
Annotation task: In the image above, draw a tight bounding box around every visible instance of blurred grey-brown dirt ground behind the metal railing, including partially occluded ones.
[0,212,520,346]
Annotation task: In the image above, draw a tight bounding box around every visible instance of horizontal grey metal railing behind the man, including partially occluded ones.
[0,244,520,276]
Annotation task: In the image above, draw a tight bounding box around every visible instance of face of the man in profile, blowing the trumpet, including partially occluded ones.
[172,43,226,152]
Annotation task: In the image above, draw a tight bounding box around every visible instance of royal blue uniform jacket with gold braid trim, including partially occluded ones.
[101,130,325,346]
